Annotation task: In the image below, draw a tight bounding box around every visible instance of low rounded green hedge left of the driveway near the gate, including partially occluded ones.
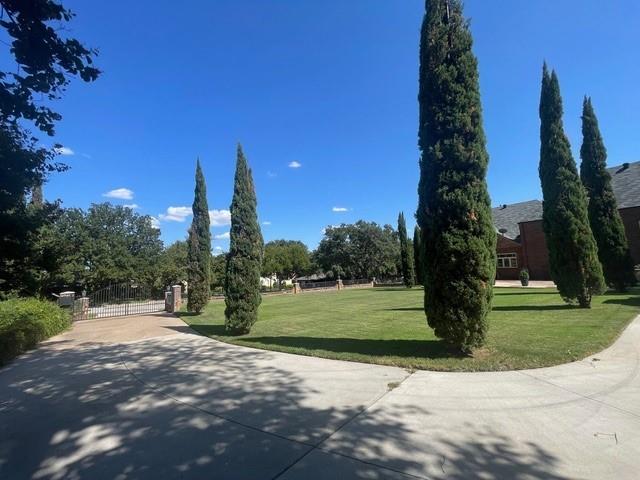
[0,298,71,366]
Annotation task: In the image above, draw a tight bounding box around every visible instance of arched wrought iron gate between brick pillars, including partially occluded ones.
[73,283,164,320]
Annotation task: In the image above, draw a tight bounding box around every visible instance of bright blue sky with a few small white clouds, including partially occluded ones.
[38,0,640,251]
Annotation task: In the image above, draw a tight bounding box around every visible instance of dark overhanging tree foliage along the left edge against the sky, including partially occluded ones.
[0,0,100,296]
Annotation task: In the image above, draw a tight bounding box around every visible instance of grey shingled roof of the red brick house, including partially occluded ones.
[492,162,640,240]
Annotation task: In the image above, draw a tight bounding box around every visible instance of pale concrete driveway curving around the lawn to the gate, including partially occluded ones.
[0,315,640,480]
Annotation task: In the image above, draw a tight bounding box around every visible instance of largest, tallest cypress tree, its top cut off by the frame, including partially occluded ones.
[417,0,496,351]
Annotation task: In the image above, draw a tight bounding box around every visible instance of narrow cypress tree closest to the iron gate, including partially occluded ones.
[187,159,211,313]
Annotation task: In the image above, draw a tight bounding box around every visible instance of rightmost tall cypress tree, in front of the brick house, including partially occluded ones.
[580,97,636,292]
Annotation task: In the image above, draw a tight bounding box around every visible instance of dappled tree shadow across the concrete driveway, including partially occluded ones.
[0,336,568,480]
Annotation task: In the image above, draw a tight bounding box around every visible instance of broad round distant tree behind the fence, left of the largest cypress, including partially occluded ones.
[314,220,400,279]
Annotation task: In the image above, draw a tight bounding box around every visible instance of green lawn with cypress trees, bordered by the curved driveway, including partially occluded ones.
[181,288,640,371]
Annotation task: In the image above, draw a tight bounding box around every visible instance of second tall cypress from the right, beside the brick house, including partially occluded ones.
[539,64,604,308]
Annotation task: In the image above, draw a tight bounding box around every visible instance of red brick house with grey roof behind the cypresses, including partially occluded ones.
[492,162,640,280]
